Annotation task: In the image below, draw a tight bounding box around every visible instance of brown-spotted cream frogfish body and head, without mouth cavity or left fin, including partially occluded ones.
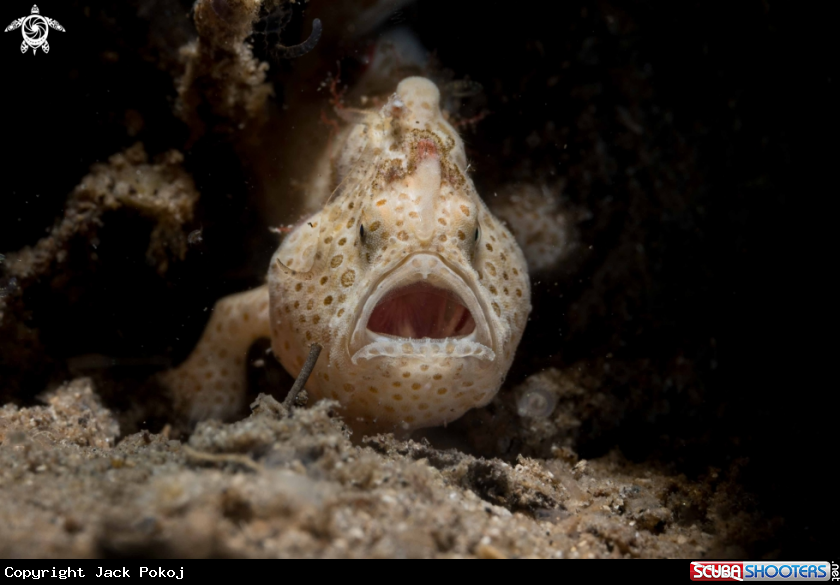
[269,78,531,429]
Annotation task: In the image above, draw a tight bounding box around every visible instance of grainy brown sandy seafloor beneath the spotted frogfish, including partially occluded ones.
[0,379,764,558]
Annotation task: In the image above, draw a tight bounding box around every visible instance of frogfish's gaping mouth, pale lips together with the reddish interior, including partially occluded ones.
[349,253,496,364]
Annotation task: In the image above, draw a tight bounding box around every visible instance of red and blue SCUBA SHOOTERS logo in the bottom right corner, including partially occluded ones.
[690,561,838,581]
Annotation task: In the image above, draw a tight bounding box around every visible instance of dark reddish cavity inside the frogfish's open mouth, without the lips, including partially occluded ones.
[367,282,475,339]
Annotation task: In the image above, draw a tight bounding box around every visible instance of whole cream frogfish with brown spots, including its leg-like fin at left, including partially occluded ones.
[164,77,531,432]
